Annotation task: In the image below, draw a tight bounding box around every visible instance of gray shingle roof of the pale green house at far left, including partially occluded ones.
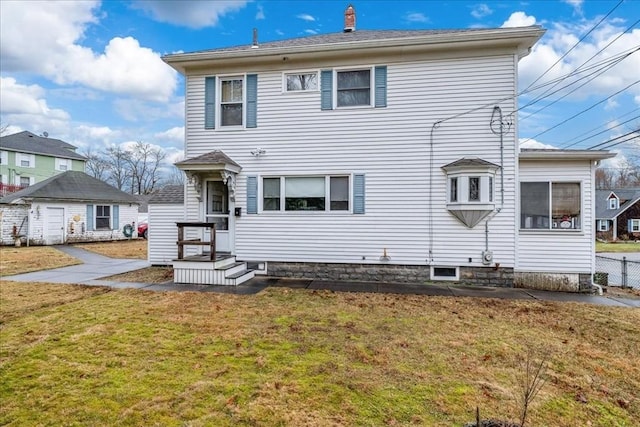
[0,131,87,160]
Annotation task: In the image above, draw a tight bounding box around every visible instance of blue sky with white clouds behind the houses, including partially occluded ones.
[0,0,640,167]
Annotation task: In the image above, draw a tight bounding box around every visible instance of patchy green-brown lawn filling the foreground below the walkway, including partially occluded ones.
[0,281,640,427]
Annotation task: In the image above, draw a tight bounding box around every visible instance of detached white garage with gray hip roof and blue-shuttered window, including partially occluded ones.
[0,171,138,245]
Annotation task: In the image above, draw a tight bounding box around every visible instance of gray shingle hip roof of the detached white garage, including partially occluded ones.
[0,171,138,205]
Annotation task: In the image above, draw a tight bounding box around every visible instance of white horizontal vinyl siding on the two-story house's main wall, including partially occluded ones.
[185,54,516,267]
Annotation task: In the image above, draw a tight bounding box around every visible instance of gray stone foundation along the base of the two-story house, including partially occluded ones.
[267,262,513,287]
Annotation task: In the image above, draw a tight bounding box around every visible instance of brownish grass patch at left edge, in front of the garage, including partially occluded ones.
[0,246,81,276]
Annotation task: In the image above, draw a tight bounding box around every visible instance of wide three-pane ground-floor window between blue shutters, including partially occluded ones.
[262,175,350,212]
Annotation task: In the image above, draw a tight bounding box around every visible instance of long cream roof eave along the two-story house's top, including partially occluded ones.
[162,26,545,74]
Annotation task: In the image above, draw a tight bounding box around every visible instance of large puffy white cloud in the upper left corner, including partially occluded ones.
[0,1,177,102]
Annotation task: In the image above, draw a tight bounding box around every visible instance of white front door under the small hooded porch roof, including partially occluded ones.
[203,181,233,252]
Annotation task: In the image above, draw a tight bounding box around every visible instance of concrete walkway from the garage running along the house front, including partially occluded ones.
[2,245,640,308]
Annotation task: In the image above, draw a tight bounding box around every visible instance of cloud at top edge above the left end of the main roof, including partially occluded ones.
[133,0,247,29]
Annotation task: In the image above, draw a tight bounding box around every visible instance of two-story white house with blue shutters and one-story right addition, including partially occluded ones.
[158,8,609,290]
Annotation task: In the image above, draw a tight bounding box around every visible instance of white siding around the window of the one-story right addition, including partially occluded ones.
[516,161,595,273]
